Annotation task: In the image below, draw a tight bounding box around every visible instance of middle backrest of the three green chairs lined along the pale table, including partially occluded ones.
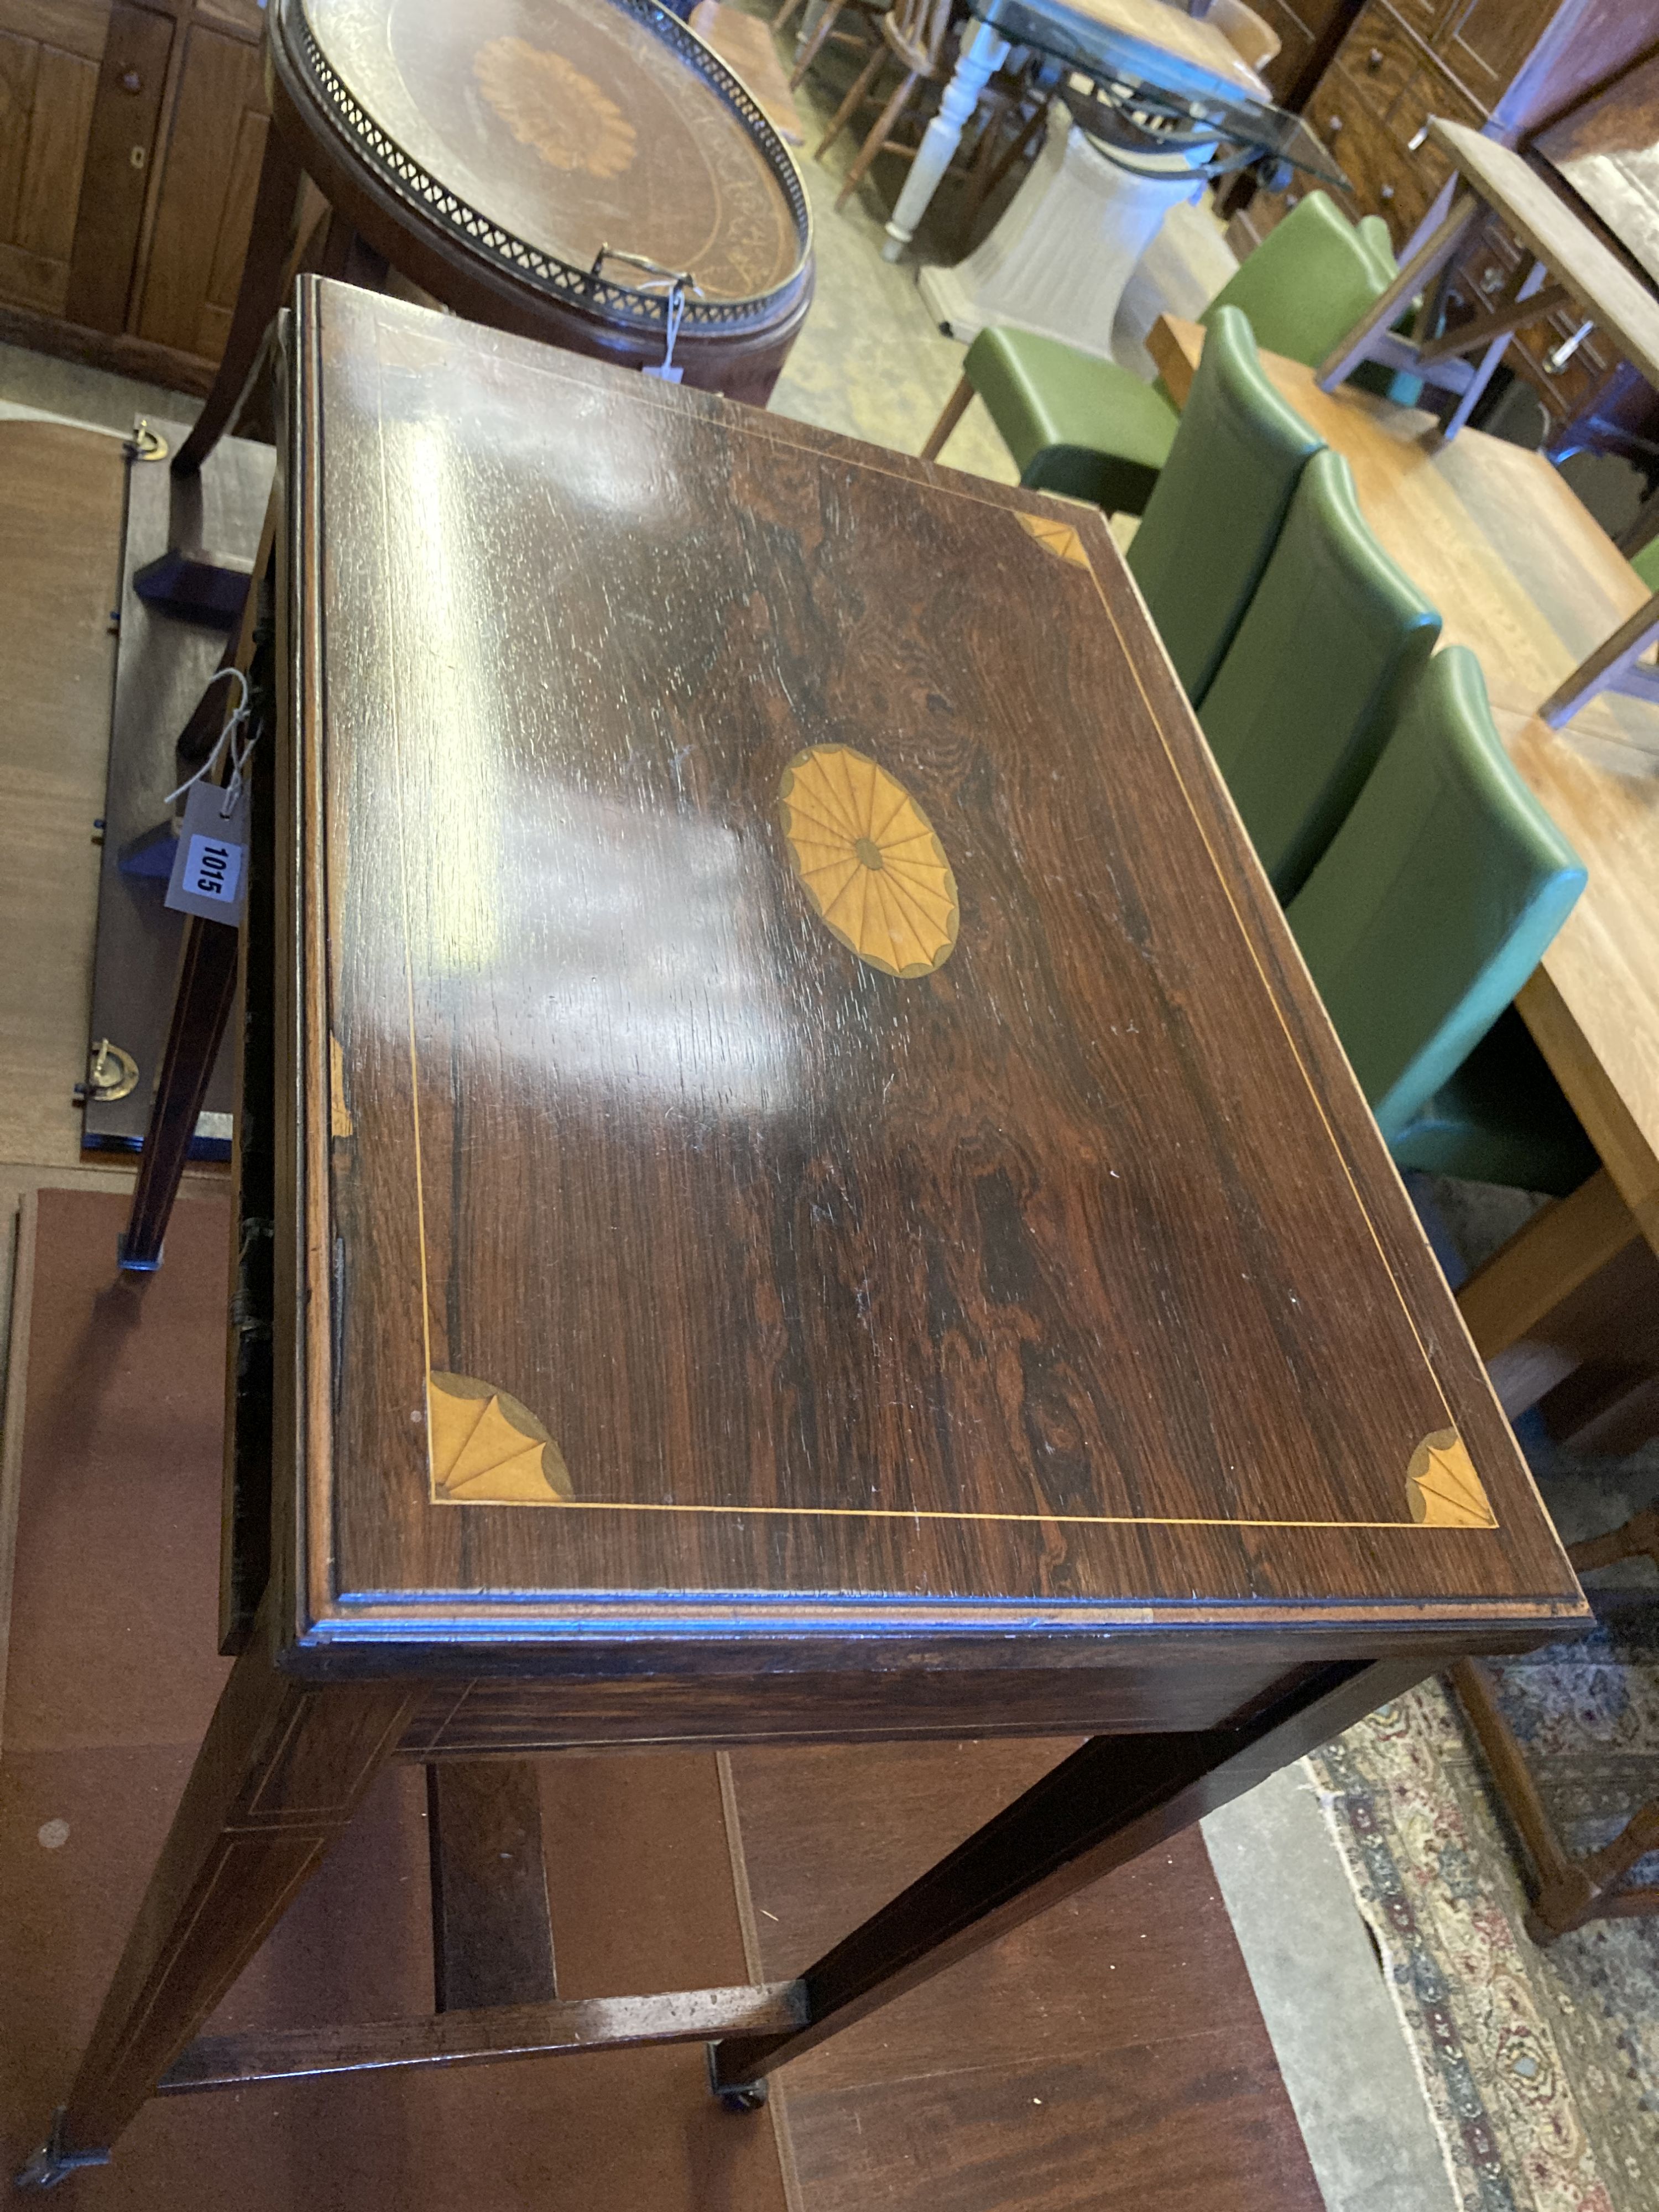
[1199,449,1440,900]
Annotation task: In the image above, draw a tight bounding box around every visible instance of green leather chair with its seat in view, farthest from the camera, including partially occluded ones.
[922,192,1398,515]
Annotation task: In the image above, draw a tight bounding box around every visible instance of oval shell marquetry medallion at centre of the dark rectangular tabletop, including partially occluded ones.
[779,745,960,978]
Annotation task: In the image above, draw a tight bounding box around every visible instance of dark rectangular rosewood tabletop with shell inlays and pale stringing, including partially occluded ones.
[279,281,1579,1672]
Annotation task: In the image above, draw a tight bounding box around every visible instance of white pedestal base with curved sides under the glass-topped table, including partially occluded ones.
[918,100,1214,361]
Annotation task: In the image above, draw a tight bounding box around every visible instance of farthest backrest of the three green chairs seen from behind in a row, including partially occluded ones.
[1128,307,1323,706]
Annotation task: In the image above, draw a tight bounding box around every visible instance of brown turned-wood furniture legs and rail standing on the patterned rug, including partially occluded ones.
[1451,1511,1659,1942]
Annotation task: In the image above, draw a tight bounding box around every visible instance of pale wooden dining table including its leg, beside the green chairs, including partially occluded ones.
[1148,316,1659,1438]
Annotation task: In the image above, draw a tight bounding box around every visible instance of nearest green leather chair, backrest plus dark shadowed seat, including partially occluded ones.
[1287,646,1597,1197]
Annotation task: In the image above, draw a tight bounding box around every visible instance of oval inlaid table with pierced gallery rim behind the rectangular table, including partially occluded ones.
[173,0,812,473]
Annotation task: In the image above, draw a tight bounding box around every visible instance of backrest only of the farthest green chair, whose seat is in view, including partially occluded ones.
[1199,192,1398,367]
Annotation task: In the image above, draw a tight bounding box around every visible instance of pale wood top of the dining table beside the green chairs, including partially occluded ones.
[1148,316,1659,1245]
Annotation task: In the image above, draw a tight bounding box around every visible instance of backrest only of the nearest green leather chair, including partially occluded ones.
[1290,646,1584,1139]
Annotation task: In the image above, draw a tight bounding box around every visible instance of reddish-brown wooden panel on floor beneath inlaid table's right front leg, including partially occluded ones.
[732,1743,1321,2212]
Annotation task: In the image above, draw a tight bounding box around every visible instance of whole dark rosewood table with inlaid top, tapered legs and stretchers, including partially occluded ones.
[29,279,1584,2183]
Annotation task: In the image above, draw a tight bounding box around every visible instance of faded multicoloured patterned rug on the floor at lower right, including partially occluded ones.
[1307,1615,1659,2212]
